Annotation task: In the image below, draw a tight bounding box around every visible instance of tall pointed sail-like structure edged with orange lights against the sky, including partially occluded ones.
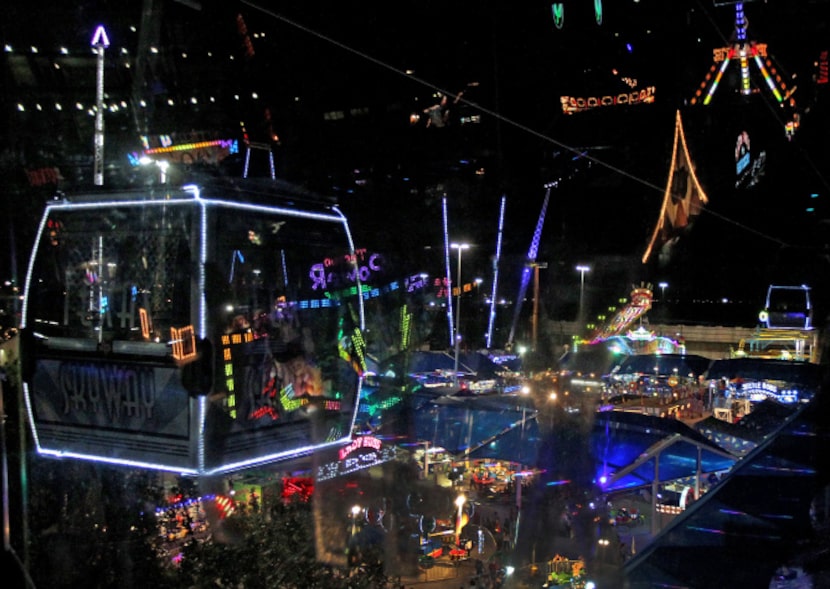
[643,111,709,264]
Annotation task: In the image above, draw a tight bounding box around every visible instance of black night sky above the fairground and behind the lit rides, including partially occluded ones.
[2,0,830,322]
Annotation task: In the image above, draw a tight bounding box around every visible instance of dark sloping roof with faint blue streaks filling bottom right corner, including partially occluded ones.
[624,395,830,588]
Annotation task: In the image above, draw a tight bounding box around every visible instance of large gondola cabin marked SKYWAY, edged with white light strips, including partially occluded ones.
[21,180,364,474]
